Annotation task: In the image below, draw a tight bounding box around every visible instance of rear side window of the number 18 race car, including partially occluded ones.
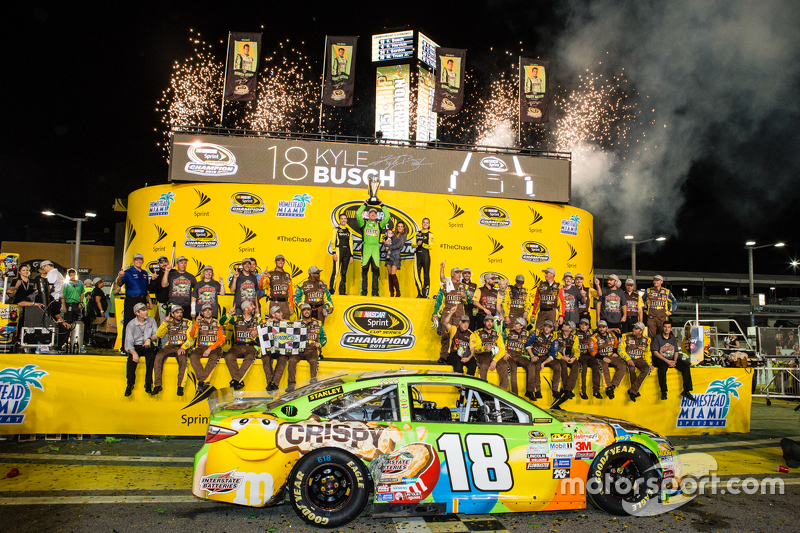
[311,385,400,422]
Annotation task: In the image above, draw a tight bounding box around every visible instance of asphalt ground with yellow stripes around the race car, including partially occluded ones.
[0,399,800,533]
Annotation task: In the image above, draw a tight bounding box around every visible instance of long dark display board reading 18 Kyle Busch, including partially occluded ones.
[169,133,571,203]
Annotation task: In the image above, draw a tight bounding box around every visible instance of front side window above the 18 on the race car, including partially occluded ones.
[409,383,530,424]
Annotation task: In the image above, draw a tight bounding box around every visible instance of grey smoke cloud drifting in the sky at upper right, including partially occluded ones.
[553,0,800,245]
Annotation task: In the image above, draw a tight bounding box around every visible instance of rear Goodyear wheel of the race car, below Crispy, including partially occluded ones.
[289,448,371,528]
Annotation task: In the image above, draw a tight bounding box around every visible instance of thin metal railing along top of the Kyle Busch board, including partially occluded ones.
[172,126,572,159]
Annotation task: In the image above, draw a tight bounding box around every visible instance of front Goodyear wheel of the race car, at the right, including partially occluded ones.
[586,443,661,516]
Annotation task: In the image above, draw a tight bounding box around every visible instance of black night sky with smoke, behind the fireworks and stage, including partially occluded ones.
[0,0,800,274]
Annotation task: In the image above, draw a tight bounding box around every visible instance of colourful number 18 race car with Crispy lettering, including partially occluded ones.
[193,369,680,528]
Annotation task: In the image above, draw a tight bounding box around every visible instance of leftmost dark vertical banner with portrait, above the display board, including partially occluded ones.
[225,31,261,102]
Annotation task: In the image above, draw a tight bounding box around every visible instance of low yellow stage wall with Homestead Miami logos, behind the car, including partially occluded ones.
[0,355,753,436]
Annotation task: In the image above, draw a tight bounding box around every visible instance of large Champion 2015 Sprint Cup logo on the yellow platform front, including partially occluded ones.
[339,304,416,351]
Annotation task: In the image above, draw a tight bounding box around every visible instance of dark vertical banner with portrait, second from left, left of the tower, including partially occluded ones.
[322,35,358,107]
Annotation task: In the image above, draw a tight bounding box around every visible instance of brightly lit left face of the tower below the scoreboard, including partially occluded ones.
[375,64,411,140]
